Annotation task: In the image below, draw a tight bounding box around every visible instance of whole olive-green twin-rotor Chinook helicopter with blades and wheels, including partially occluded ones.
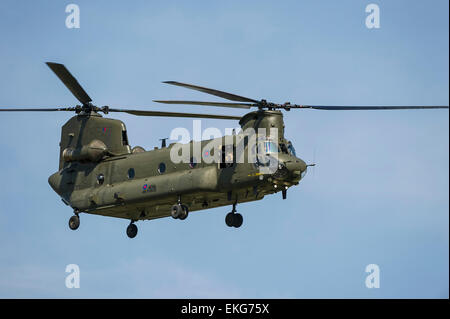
[0,62,448,238]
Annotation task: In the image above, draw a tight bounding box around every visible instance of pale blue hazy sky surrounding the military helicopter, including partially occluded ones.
[0,0,449,298]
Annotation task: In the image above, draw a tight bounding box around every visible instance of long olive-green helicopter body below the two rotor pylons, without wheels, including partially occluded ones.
[49,139,306,220]
